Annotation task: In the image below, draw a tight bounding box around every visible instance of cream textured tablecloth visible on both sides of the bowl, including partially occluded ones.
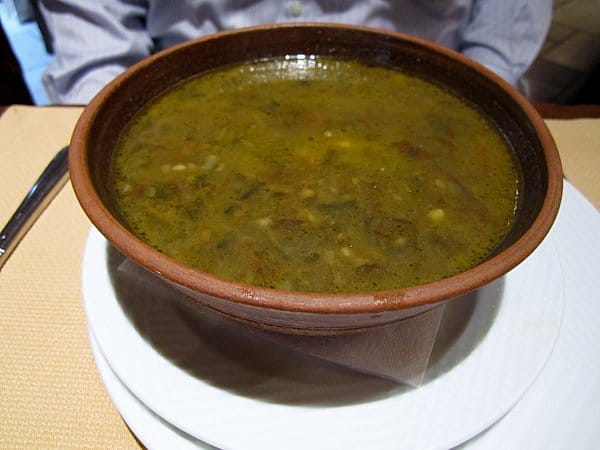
[0,105,600,448]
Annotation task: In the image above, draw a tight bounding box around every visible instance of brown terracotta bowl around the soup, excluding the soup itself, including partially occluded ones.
[69,24,562,334]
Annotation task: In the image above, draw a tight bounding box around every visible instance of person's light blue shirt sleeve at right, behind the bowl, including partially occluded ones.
[460,0,552,85]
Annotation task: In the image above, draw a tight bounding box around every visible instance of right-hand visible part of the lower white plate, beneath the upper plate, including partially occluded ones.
[466,182,600,450]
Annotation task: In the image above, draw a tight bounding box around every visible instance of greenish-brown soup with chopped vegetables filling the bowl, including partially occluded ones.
[113,56,520,293]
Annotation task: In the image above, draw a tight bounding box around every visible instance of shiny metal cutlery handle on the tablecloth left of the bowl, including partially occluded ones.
[0,147,69,269]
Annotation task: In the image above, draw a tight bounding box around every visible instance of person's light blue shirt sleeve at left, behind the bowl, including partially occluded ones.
[40,0,153,104]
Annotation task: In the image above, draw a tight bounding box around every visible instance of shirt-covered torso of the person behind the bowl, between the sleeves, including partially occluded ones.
[147,0,473,50]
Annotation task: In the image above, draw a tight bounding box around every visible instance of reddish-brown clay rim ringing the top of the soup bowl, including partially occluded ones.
[69,22,563,314]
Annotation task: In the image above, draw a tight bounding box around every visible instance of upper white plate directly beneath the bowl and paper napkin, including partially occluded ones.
[83,186,563,449]
